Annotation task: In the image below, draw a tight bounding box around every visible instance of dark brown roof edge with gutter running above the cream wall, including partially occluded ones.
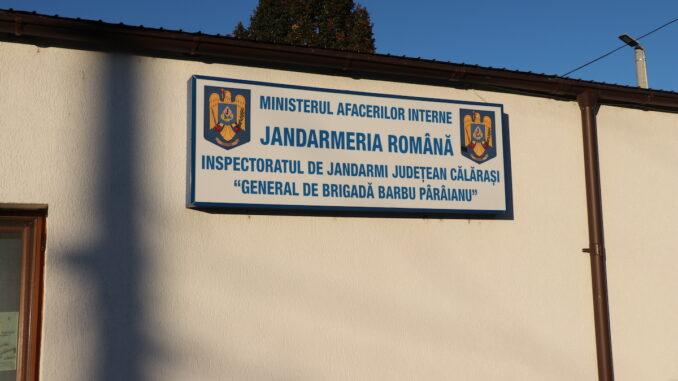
[0,9,678,112]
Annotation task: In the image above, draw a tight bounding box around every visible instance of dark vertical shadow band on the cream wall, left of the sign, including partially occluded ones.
[66,55,152,381]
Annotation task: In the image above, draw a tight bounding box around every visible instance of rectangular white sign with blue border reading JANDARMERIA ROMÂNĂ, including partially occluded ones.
[188,76,509,214]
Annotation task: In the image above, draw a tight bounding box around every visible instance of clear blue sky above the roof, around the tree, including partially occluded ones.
[5,0,678,91]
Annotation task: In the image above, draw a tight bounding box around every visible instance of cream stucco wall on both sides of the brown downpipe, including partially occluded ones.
[0,43,678,381]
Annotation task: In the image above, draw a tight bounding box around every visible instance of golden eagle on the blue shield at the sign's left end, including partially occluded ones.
[209,89,247,147]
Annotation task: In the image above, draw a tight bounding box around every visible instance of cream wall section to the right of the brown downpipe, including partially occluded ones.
[598,107,678,381]
